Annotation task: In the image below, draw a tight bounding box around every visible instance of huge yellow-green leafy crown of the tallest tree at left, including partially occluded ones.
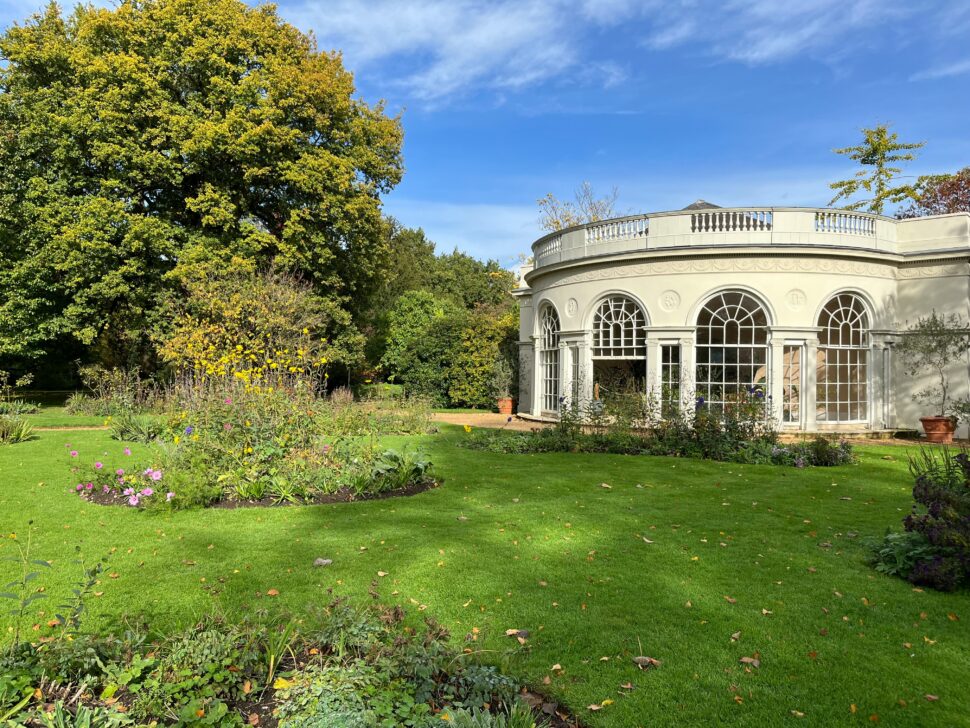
[0,0,403,364]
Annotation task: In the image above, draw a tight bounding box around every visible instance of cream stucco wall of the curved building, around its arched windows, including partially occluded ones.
[516,208,970,429]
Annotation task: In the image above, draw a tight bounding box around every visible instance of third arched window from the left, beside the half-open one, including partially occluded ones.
[695,291,768,416]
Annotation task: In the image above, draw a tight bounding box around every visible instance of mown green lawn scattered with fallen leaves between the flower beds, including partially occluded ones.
[0,428,970,726]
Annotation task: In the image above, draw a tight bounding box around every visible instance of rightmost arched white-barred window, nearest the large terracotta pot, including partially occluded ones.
[815,293,869,422]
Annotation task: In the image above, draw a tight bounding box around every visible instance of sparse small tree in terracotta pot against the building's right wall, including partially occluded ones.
[898,311,970,443]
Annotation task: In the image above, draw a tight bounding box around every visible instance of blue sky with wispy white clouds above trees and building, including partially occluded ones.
[0,0,970,264]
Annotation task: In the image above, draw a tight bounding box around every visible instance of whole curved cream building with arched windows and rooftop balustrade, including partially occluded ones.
[515,201,970,432]
